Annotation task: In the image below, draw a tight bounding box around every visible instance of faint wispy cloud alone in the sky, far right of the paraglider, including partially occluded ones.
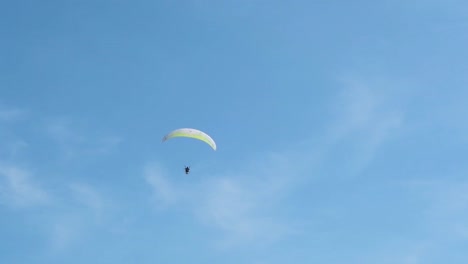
[322,77,405,176]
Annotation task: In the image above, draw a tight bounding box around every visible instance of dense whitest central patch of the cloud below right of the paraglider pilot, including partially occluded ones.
[192,172,294,247]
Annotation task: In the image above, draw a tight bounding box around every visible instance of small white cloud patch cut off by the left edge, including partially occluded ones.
[0,165,50,207]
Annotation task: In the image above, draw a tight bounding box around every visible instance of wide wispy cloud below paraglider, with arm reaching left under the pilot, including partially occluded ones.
[145,151,300,247]
